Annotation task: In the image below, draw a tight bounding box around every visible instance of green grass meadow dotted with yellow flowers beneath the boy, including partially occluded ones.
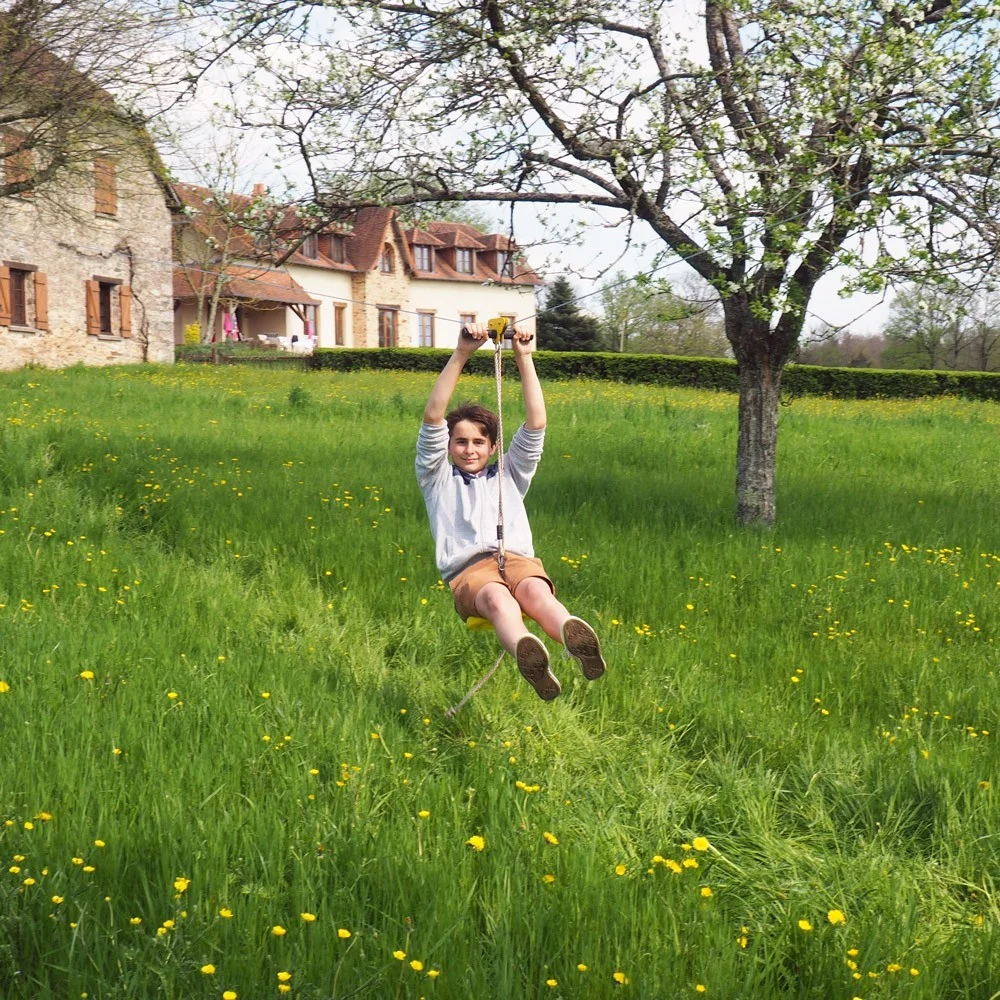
[0,367,1000,1000]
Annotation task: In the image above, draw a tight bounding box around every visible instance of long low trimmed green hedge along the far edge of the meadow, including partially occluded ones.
[307,348,1000,400]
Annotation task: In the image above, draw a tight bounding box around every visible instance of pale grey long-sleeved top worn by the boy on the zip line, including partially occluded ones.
[416,424,545,581]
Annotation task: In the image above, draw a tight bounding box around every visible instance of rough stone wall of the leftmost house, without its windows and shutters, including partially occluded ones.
[0,147,173,369]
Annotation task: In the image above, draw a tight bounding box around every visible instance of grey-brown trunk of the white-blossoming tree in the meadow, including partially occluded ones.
[724,297,795,527]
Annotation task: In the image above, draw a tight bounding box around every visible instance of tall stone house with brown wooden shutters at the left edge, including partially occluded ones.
[0,57,173,368]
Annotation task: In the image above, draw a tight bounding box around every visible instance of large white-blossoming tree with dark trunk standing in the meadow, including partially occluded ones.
[194,0,1000,524]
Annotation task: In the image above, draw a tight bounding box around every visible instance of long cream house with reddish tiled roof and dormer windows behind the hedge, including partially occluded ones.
[173,184,541,350]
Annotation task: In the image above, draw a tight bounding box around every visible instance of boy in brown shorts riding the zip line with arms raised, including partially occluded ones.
[416,326,605,701]
